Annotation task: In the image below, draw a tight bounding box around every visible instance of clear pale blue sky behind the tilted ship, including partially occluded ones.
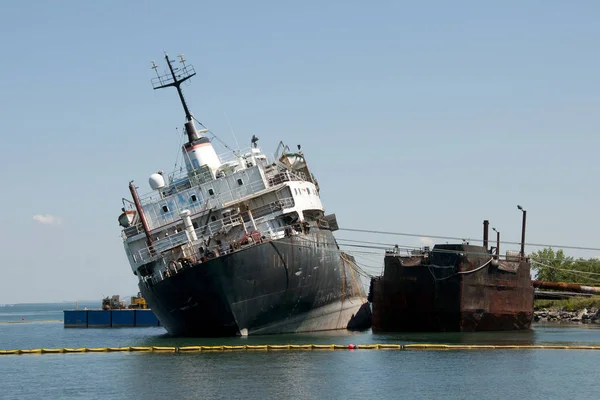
[0,0,600,303]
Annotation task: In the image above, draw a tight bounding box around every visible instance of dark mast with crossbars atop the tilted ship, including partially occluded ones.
[152,53,200,143]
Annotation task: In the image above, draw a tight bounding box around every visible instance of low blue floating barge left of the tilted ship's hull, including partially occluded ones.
[64,309,160,328]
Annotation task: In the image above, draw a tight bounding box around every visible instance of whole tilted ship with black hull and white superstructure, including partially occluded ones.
[119,55,370,337]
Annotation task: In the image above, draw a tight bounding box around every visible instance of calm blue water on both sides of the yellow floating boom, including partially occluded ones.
[0,303,600,400]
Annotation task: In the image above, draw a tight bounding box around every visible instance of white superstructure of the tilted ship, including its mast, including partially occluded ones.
[119,53,335,281]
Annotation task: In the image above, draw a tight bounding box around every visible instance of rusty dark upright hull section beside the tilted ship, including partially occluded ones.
[369,221,534,332]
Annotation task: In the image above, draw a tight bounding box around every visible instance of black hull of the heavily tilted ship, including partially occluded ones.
[139,230,370,337]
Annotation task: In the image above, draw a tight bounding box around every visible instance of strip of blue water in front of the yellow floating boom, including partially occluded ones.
[0,346,600,400]
